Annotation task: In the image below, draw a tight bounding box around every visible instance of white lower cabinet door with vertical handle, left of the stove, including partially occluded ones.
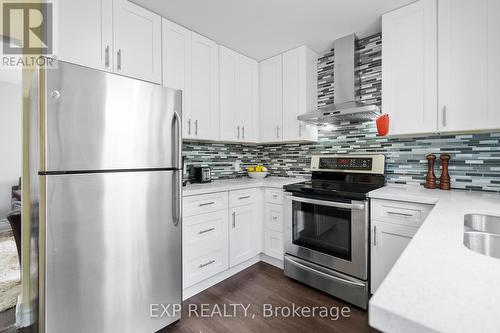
[229,204,257,267]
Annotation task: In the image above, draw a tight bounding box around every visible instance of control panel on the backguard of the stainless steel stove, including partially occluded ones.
[311,155,385,174]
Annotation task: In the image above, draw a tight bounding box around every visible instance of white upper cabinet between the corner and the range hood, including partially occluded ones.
[260,46,318,142]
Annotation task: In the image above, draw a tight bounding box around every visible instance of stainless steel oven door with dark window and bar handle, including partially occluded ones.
[284,193,369,280]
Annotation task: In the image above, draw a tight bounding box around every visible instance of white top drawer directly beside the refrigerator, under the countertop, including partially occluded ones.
[182,192,228,217]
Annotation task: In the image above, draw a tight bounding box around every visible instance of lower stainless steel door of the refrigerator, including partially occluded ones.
[44,171,182,333]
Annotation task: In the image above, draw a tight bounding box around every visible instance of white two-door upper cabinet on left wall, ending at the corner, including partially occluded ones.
[219,46,259,142]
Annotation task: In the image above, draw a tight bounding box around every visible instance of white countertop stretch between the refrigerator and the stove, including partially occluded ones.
[182,177,304,197]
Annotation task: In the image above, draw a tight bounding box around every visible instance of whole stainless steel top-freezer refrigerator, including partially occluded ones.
[30,61,182,333]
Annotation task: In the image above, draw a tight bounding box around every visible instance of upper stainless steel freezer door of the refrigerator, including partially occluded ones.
[42,61,181,171]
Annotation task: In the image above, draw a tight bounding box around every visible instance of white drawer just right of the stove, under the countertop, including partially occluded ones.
[371,199,434,227]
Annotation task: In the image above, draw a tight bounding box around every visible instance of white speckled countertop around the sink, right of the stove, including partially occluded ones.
[369,185,500,332]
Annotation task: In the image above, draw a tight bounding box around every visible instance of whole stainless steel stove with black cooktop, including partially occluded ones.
[283,155,385,309]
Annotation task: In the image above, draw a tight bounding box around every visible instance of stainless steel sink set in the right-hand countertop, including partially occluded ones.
[464,214,500,259]
